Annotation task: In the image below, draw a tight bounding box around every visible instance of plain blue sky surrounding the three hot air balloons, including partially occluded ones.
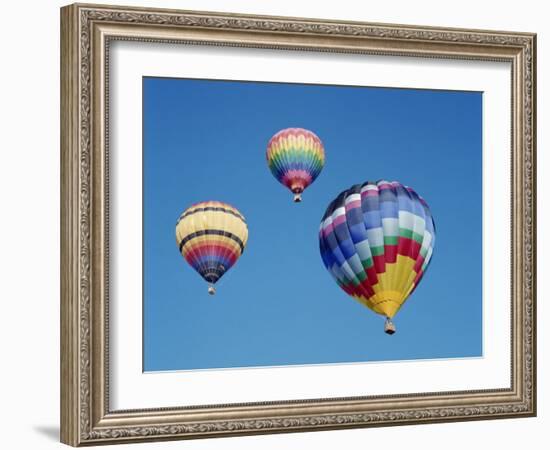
[143,78,482,371]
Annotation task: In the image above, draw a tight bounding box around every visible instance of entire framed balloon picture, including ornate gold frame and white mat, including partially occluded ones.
[61,4,536,446]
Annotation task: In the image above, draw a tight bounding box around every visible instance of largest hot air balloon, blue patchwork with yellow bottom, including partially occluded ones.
[319,181,435,334]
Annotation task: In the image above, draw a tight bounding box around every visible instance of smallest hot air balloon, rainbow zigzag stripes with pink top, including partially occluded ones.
[266,128,325,202]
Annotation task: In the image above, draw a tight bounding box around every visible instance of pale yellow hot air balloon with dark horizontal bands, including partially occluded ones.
[176,201,248,295]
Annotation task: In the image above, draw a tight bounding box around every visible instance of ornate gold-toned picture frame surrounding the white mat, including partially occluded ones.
[61,4,536,446]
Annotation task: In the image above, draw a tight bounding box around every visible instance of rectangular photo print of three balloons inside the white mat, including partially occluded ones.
[143,77,483,372]
